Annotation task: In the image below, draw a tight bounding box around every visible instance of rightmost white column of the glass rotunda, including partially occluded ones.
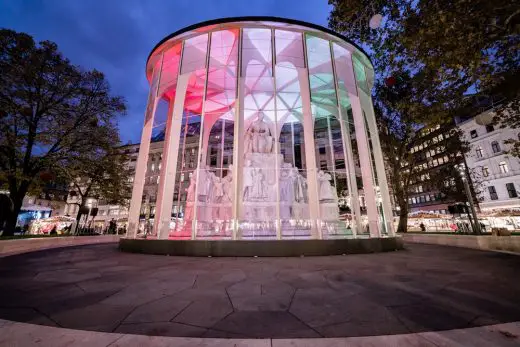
[359,91,395,236]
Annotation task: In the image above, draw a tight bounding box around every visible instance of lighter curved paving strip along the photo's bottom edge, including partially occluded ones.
[0,320,520,347]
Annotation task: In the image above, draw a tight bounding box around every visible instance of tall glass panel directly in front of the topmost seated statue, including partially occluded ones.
[241,29,280,239]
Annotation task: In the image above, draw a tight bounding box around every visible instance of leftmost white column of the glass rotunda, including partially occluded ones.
[126,96,159,238]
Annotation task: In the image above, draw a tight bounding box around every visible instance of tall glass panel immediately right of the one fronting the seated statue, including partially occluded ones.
[275,30,312,239]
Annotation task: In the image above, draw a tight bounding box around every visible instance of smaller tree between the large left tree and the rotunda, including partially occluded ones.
[59,137,132,232]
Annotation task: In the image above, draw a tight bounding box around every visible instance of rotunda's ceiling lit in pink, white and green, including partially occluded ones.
[151,22,372,125]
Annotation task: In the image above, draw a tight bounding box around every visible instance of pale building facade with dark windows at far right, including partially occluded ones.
[458,109,520,212]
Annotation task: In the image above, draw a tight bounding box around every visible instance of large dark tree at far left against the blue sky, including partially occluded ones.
[0,29,125,237]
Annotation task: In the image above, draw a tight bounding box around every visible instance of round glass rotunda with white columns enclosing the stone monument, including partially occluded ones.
[127,17,394,240]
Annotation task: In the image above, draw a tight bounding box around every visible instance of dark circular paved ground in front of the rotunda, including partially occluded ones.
[0,244,520,338]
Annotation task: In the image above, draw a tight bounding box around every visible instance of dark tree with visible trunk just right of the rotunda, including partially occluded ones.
[374,74,467,232]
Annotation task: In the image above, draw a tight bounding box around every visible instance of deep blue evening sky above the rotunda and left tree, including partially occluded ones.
[0,0,330,143]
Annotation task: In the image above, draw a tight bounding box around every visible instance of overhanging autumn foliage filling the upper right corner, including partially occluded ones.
[329,0,520,136]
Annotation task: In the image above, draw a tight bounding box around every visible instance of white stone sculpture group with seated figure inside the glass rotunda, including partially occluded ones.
[185,113,338,237]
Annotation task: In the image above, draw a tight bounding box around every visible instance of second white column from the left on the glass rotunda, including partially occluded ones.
[155,73,191,239]
